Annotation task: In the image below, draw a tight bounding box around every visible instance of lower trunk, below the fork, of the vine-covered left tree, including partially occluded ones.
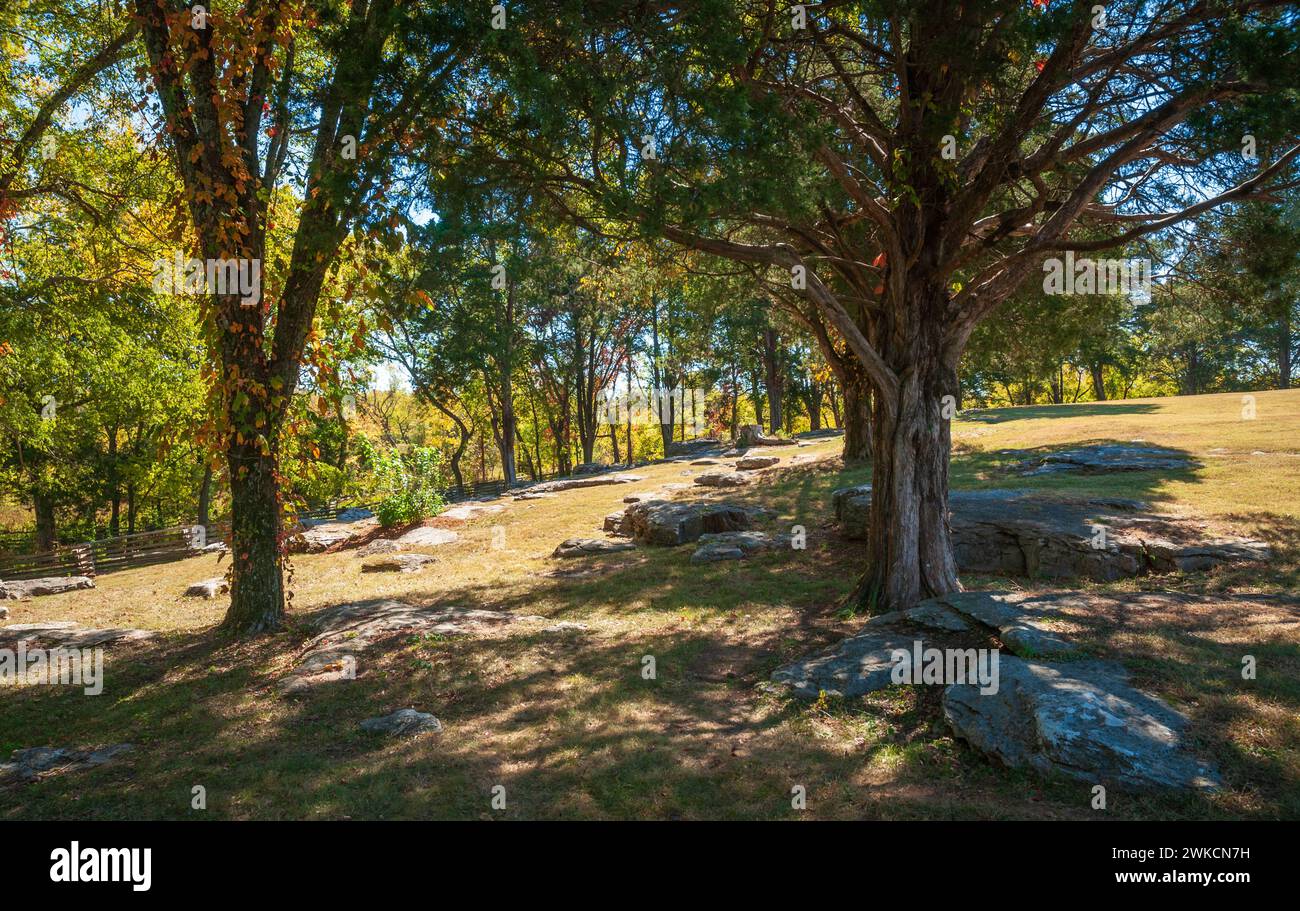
[222,441,285,633]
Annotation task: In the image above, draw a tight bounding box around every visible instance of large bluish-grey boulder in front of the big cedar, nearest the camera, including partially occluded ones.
[943,655,1218,789]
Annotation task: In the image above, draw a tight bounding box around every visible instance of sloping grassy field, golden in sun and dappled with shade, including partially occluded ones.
[0,390,1300,819]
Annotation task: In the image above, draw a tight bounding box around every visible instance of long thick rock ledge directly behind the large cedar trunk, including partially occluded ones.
[832,485,1273,582]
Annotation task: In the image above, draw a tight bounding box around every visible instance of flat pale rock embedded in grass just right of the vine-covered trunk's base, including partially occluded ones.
[277,599,543,695]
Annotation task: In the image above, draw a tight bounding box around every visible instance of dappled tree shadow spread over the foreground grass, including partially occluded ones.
[0,444,1300,819]
